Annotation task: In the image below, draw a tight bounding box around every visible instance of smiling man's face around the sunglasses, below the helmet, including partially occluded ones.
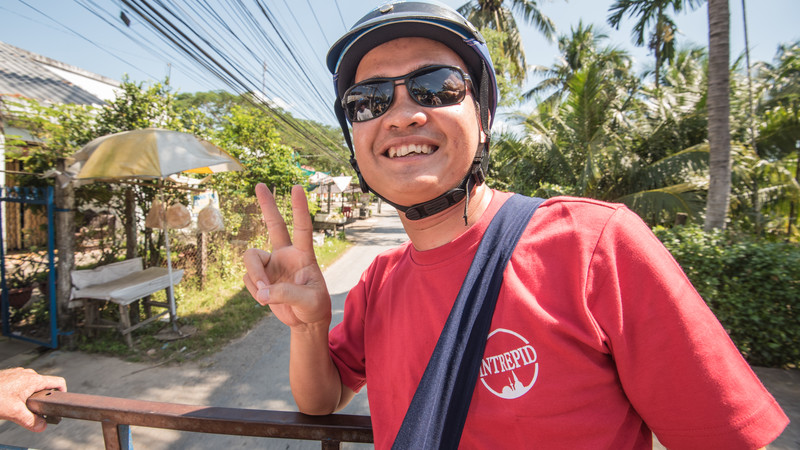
[353,38,482,209]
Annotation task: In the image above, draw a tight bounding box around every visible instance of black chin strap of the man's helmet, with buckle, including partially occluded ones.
[333,66,489,226]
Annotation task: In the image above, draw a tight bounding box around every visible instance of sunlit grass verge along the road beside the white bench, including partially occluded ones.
[76,239,352,363]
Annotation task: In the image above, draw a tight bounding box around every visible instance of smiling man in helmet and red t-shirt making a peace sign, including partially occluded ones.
[239,1,788,449]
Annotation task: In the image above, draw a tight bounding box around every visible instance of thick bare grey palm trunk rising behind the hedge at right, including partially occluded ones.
[704,0,731,230]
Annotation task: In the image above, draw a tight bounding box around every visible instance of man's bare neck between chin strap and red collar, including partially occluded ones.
[398,184,492,251]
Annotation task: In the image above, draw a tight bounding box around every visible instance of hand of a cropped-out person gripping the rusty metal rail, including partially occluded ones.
[0,367,67,432]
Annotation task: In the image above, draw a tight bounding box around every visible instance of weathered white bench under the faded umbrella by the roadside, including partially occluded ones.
[70,258,183,347]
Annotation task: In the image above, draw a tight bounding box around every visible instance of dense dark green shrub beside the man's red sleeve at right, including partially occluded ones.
[654,226,800,367]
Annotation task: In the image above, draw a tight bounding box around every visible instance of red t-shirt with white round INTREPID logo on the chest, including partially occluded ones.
[330,191,788,449]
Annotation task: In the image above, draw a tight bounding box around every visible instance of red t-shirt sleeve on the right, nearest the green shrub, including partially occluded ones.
[586,208,788,449]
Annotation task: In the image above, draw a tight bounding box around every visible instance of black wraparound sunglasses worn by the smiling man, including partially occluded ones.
[342,65,470,123]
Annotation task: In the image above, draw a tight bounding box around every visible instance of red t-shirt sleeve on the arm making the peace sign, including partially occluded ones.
[328,271,369,392]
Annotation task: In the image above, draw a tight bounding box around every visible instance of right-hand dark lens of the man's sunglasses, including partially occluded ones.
[408,67,467,106]
